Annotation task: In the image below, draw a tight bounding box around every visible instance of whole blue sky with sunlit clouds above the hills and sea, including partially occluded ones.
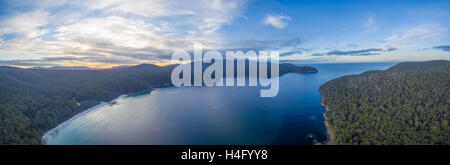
[0,0,450,68]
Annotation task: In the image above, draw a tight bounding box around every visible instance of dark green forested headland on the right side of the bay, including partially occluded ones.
[319,60,450,144]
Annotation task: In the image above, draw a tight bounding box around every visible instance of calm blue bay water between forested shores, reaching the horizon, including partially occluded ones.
[43,63,395,145]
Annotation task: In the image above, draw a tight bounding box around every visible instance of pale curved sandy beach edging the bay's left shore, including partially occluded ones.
[41,94,128,145]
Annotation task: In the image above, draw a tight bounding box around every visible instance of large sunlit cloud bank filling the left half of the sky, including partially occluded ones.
[0,0,245,67]
